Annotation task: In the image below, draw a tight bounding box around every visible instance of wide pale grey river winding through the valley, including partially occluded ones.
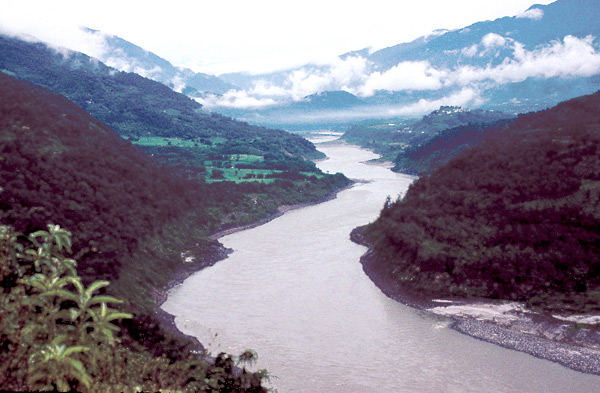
[163,141,600,393]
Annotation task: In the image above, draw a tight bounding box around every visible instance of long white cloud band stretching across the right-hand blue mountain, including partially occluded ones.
[203,33,600,108]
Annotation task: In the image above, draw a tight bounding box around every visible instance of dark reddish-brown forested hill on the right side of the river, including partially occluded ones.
[354,93,600,311]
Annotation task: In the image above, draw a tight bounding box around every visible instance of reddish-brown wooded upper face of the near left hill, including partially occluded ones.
[0,73,214,290]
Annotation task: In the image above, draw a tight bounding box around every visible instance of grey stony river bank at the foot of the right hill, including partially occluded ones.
[350,229,600,375]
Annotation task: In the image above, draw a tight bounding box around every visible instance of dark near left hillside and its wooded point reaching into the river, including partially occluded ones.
[0,73,349,391]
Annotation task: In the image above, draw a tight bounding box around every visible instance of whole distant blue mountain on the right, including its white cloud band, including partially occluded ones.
[211,0,600,127]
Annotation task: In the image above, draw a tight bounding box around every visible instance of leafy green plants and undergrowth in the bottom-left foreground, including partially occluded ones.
[0,225,267,392]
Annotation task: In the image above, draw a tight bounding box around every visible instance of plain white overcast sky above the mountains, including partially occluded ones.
[0,0,552,75]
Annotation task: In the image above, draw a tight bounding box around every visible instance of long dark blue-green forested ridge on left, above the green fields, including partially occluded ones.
[0,35,322,158]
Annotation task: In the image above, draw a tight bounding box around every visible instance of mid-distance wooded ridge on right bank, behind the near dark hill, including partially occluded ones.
[341,106,513,170]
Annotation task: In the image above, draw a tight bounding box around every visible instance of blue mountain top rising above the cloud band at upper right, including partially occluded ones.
[368,0,600,70]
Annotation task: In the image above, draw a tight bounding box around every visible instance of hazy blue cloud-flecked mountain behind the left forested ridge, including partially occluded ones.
[85,29,235,94]
